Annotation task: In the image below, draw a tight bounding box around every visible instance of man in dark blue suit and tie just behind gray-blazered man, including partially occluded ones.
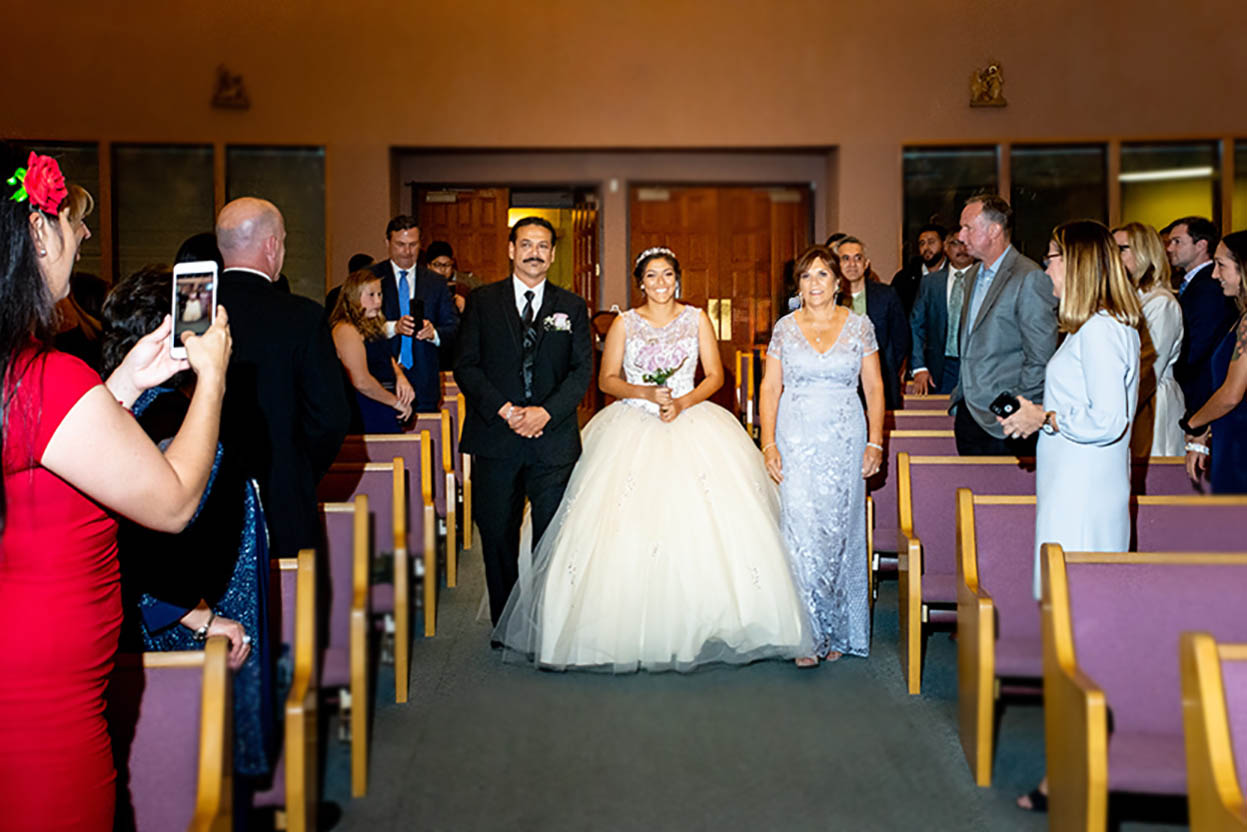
[909,235,974,395]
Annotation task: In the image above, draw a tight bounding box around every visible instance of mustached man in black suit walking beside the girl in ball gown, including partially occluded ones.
[455,217,592,624]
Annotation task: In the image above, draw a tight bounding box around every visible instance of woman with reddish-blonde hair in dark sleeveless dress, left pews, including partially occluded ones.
[329,268,415,433]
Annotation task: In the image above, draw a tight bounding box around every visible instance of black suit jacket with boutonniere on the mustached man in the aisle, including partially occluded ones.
[455,277,594,464]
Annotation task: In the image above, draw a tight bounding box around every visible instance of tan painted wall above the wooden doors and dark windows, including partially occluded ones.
[7,0,1247,299]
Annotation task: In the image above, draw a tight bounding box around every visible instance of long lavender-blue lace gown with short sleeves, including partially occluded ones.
[768,312,878,656]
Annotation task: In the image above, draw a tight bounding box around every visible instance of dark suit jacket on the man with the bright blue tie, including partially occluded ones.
[368,259,459,412]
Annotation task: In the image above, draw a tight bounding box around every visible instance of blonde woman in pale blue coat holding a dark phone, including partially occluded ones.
[998,220,1142,811]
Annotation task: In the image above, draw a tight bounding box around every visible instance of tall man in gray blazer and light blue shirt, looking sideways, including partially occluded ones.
[951,195,1056,457]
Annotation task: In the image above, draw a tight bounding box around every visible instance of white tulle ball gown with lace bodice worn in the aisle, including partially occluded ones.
[494,307,813,672]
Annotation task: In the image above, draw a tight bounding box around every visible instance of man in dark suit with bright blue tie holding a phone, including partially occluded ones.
[370,215,459,413]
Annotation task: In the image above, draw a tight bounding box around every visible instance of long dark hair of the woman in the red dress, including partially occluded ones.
[0,142,60,533]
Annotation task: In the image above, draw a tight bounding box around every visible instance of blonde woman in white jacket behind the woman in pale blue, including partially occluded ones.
[1112,222,1186,457]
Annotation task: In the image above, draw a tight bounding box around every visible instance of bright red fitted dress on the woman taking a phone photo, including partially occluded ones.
[0,352,121,832]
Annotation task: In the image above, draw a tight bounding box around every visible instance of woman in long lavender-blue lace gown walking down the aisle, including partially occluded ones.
[759,246,884,667]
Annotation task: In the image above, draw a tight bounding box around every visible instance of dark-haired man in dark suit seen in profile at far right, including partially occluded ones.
[1165,217,1238,413]
